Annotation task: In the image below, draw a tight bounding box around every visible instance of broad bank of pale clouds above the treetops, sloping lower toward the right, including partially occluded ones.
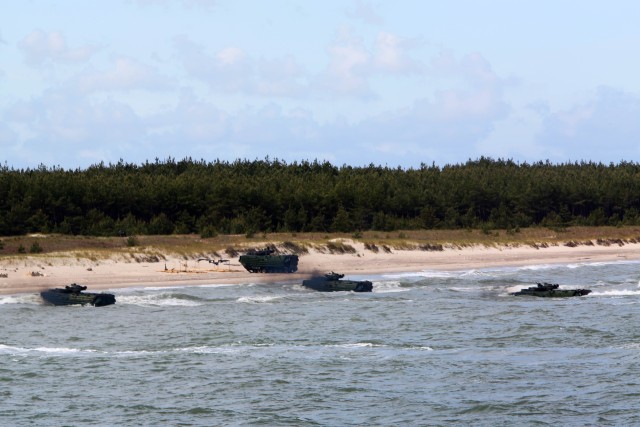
[0,0,640,168]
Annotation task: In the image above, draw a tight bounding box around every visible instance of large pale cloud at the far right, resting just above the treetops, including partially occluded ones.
[477,87,640,163]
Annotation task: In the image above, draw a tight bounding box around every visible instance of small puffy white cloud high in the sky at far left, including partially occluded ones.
[18,30,97,66]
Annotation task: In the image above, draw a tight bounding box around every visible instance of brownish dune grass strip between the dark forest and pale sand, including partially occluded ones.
[0,227,640,262]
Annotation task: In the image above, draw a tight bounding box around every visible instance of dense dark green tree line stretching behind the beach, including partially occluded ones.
[0,157,640,237]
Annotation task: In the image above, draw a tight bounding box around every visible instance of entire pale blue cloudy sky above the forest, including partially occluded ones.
[0,0,640,169]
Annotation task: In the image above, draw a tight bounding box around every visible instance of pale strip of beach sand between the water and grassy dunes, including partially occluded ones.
[0,241,640,295]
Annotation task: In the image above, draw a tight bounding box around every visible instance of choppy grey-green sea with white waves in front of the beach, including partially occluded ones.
[0,262,640,427]
